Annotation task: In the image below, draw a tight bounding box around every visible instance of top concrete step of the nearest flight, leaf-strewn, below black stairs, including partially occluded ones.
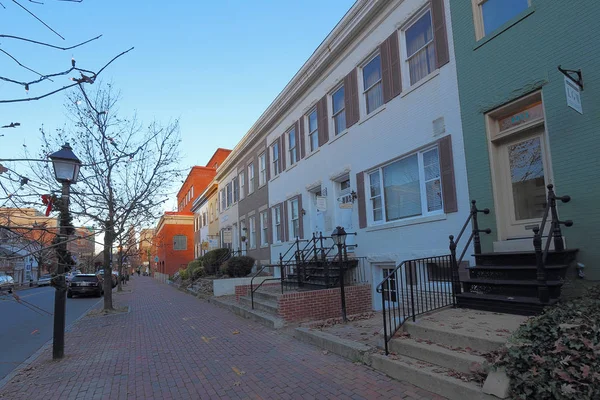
[402,319,506,353]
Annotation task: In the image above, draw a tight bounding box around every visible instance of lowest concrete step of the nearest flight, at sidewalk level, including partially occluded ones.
[371,354,498,400]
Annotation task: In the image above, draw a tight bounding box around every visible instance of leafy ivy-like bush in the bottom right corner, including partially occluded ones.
[495,286,600,400]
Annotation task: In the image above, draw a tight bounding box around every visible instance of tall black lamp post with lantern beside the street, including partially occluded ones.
[48,143,81,360]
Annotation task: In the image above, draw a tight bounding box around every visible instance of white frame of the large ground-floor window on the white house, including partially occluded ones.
[364,145,444,226]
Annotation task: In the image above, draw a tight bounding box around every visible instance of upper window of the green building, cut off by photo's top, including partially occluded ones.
[473,0,531,39]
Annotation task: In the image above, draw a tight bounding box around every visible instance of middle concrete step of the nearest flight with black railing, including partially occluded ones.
[388,338,486,374]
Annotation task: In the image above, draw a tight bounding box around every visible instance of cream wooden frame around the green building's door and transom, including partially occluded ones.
[484,90,554,241]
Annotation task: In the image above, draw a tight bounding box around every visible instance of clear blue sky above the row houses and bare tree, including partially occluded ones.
[0,0,354,177]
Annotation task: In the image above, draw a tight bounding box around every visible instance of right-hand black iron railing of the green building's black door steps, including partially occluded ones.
[533,184,573,303]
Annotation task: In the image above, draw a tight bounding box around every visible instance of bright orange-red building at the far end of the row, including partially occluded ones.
[153,148,231,279]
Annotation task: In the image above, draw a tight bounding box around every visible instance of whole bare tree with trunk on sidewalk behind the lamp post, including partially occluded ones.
[38,84,182,310]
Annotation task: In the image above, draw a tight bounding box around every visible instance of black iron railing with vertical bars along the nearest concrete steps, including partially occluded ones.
[376,254,457,354]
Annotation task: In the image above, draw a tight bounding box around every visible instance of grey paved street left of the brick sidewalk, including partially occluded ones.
[0,286,98,380]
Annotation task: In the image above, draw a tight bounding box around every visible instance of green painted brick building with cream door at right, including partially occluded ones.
[450,0,600,280]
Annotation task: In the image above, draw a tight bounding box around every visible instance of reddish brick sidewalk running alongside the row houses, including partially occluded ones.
[0,276,442,400]
